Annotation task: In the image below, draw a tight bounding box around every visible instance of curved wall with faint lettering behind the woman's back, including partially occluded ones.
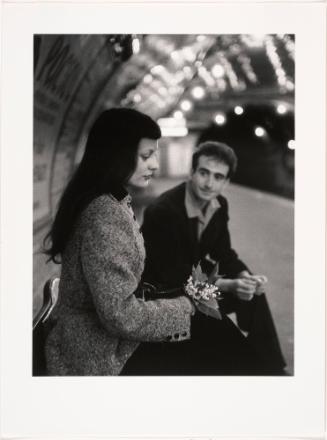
[33,35,120,314]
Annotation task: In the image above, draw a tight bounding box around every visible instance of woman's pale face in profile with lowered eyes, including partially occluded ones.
[128,138,159,188]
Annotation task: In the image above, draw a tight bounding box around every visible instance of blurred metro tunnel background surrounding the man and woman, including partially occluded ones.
[33,34,295,374]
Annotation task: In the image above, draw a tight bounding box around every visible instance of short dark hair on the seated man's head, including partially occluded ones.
[192,141,237,178]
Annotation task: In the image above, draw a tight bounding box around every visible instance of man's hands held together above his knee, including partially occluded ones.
[216,271,267,301]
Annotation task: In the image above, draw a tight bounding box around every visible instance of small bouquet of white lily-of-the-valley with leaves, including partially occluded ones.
[184,264,222,319]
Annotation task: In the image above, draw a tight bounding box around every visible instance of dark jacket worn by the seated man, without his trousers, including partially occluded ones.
[142,183,247,287]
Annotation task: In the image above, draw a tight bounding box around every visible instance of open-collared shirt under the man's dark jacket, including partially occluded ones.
[185,181,220,240]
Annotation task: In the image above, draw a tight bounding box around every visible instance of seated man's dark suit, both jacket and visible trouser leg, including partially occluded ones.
[142,183,285,372]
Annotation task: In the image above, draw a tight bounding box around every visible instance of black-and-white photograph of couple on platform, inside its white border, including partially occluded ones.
[33,34,296,376]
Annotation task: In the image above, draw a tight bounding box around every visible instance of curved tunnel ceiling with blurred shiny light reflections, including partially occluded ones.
[114,34,294,121]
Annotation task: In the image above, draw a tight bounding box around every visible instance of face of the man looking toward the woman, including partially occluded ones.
[191,156,229,202]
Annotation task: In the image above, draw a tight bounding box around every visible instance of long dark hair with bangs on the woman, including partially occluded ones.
[44,108,161,263]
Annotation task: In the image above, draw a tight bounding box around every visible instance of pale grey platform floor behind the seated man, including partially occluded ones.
[137,178,294,374]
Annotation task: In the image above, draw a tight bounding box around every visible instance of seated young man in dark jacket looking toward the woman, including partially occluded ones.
[142,142,285,374]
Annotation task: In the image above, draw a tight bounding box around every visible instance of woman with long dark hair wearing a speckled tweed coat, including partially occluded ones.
[46,109,194,376]
